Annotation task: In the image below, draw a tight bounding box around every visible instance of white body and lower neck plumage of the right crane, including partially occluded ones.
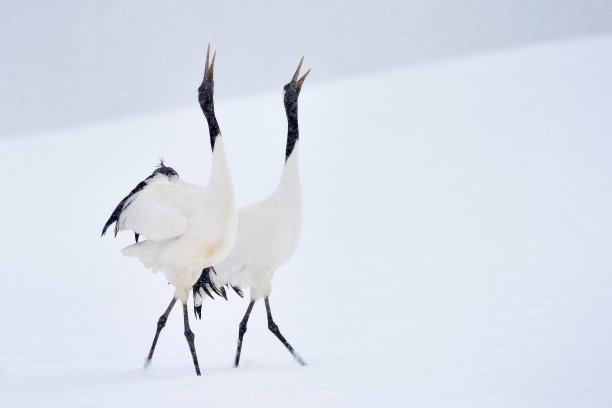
[209,143,302,304]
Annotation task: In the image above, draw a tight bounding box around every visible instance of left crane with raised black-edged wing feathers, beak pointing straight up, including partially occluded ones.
[102,45,237,375]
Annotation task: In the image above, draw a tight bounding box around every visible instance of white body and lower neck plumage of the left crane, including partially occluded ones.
[119,137,237,303]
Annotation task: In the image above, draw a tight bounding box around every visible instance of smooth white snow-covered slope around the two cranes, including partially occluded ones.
[0,36,612,408]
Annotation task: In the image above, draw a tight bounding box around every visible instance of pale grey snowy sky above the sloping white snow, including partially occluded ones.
[0,0,612,137]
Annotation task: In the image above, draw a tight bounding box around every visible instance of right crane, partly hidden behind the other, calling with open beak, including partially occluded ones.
[193,58,310,367]
